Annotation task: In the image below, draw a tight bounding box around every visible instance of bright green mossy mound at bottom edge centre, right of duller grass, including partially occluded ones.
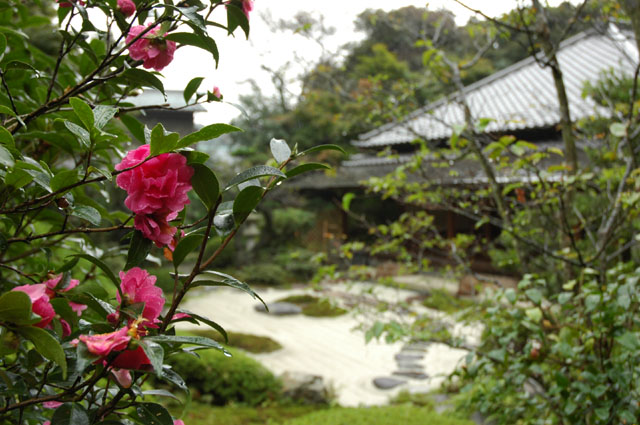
[283,405,473,425]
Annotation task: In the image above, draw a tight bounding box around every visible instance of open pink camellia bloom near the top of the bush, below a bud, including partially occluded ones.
[126,25,176,71]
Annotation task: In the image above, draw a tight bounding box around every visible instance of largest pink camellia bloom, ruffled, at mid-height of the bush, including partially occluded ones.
[115,145,193,217]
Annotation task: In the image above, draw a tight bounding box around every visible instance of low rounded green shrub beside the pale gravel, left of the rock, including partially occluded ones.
[168,350,281,406]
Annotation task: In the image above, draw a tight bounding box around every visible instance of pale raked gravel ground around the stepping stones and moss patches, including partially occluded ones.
[180,283,480,406]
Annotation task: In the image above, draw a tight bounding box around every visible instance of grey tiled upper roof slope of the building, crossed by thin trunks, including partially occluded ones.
[352,29,638,148]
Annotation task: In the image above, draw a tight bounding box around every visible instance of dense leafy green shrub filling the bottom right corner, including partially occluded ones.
[458,264,640,424]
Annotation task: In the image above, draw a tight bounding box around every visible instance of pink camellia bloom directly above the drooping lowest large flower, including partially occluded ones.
[116,267,164,327]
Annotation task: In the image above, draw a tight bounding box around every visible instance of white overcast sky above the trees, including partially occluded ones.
[163,0,560,124]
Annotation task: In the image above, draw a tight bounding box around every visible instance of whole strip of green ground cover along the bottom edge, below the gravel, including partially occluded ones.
[175,403,474,425]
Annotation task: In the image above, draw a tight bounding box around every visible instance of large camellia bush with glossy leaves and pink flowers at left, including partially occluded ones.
[0,0,338,425]
